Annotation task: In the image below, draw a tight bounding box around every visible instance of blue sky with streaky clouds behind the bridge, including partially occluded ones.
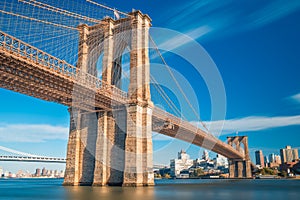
[0,0,300,171]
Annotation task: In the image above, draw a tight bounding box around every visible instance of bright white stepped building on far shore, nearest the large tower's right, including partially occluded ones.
[170,150,193,177]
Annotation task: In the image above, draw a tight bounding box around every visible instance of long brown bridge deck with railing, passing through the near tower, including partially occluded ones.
[0,31,244,159]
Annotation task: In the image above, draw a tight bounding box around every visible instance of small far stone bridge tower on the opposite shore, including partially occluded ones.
[227,136,252,178]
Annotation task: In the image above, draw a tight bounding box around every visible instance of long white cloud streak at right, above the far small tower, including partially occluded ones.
[192,115,300,135]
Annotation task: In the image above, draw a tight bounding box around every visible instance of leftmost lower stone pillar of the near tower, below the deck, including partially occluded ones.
[64,108,97,185]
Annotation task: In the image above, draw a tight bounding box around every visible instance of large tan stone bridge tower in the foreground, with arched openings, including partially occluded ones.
[64,11,154,186]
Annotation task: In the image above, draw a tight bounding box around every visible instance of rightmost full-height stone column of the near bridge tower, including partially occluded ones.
[123,11,154,186]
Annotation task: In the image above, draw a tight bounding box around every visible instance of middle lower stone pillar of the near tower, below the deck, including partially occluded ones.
[93,108,126,186]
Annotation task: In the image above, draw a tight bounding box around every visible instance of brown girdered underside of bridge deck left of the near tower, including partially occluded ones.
[0,47,123,112]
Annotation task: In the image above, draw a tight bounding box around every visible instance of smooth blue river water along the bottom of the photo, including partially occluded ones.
[0,179,300,200]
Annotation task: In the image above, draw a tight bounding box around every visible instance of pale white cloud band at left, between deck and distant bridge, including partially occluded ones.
[0,124,69,142]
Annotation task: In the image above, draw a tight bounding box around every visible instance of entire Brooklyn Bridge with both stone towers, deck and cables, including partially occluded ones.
[0,0,252,186]
